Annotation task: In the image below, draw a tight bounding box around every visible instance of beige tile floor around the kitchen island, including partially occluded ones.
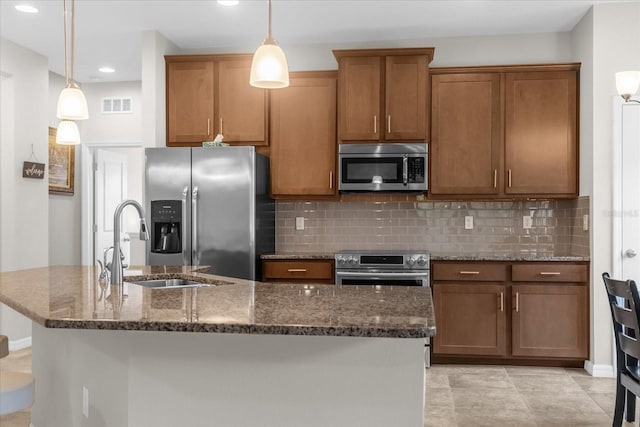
[0,349,640,427]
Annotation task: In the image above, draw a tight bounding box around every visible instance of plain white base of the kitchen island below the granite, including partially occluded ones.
[32,322,425,427]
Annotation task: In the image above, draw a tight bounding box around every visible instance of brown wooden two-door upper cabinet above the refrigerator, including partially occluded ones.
[165,54,268,147]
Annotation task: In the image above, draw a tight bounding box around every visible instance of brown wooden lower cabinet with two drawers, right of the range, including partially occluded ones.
[432,262,589,364]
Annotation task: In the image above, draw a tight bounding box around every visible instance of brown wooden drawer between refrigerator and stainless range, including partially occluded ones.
[262,260,333,282]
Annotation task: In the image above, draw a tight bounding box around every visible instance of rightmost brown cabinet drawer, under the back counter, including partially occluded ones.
[511,262,589,282]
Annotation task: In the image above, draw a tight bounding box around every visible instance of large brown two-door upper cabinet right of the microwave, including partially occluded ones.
[429,63,580,198]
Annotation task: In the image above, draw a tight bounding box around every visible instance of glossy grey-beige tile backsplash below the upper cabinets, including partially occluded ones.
[276,197,589,256]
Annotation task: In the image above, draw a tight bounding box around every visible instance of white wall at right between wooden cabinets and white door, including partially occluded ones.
[582,2,640,374]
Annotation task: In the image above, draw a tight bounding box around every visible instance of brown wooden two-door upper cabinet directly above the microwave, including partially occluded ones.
[333,48,434,142]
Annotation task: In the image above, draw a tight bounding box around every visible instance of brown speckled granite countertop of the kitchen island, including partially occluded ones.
[0,266,435,338]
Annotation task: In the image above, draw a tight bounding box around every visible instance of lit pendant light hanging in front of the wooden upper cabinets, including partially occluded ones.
[249,0,289,89]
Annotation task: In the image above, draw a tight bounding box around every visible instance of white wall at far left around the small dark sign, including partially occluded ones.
[0,38,49,342]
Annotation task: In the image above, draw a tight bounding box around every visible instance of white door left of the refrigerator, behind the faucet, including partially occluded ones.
[93,149,129,270]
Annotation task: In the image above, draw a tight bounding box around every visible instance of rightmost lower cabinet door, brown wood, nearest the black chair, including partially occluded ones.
[512,284,589,359]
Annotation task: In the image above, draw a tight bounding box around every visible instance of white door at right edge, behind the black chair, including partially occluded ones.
[614,103,640,284]
